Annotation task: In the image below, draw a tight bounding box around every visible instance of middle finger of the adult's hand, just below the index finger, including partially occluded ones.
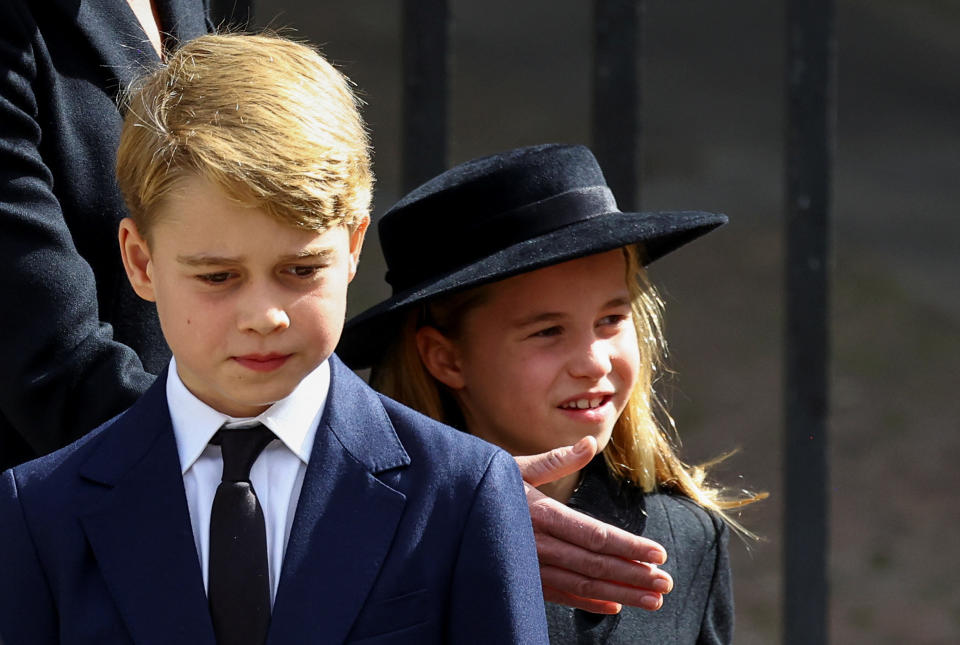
[534,533,673,592]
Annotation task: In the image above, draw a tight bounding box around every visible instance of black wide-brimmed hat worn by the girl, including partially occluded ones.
[337,144,727,369]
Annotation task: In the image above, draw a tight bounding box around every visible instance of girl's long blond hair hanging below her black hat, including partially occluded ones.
[370,246,766,537]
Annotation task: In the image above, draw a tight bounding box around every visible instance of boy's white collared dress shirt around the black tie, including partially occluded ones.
[167,359,330,605]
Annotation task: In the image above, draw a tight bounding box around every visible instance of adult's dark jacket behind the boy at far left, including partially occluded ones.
[0,0,208,468]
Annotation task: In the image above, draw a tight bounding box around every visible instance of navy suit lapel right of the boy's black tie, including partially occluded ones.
[268,356,410,643]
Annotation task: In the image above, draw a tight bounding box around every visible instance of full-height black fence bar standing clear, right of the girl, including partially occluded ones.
[783,0,836,645]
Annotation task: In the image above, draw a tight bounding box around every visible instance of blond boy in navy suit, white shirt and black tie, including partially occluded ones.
[0,35,546,645]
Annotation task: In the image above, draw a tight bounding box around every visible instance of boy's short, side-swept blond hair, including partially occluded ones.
[116,34,373,234]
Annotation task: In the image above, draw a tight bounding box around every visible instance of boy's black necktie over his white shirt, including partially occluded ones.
[207,424,274,645]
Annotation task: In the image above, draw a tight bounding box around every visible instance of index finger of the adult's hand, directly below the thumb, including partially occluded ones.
[527,490,667,564]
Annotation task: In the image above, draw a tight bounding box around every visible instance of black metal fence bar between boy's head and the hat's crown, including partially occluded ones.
[401,0,450,191]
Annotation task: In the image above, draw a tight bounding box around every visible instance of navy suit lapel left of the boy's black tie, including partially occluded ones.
[81,376,214,645]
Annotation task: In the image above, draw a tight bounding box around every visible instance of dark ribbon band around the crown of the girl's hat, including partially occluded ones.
[386,186,617,293]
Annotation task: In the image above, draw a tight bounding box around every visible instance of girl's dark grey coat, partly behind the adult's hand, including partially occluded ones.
[547,456,733,645]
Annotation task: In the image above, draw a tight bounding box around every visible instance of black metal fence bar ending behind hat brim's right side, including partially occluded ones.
[592,0,643,210]
